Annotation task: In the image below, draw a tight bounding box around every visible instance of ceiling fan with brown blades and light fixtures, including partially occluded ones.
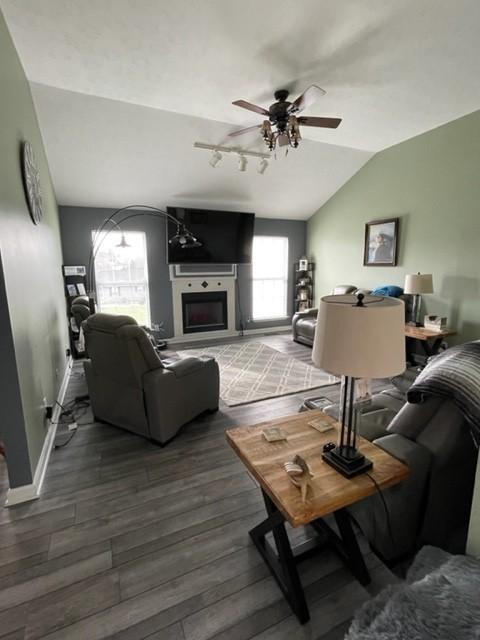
[229,84,342,151]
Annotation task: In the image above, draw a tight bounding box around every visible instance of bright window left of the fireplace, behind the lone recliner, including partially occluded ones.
[92,231,150,326]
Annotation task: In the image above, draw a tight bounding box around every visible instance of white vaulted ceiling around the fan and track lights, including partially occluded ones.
[0,0,480,219]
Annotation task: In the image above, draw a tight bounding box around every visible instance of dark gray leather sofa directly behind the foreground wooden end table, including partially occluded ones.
[350,398,477,560]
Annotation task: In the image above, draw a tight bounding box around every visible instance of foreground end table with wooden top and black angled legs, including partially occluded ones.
[226,410,409,624]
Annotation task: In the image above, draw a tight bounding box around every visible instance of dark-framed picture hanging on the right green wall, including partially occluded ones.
[363,218,399,267]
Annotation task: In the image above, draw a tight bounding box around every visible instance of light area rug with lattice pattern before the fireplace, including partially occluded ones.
[178,342,338,407]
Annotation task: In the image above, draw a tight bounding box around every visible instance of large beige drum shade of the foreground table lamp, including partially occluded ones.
[312,295,406,378]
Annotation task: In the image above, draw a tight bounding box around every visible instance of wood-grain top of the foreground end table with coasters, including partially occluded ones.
[226,410,409,527]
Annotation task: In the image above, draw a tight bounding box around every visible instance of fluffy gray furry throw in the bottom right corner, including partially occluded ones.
[345,547,480,640]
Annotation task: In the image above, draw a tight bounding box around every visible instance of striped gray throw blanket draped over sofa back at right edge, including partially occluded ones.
[407,341,480,441]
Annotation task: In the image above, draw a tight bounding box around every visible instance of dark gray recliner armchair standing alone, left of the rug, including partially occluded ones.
[83,313,219,445]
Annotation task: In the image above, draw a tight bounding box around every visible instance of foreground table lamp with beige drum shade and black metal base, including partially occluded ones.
[312,293,405,478]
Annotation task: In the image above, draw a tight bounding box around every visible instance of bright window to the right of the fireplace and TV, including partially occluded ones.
[252,236,288,320]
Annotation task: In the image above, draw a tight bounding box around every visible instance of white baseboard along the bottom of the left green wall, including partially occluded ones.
[5,356,73,507]
